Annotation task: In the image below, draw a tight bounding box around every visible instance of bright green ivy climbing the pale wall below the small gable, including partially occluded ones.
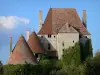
[62,43,81,65]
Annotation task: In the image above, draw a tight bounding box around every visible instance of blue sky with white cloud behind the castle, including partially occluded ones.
[0,0,100,64]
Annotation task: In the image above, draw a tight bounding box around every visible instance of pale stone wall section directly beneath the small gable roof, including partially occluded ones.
[57,33,79,59]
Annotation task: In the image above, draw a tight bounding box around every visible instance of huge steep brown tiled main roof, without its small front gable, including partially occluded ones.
[38,8,90,35]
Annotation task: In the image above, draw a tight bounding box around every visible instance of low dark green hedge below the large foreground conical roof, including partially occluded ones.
[3,64,42,75]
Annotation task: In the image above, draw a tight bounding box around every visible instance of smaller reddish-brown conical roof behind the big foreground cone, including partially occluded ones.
[28,32,44,53]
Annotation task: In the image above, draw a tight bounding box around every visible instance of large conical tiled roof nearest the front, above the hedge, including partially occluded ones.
[8,35,35,64]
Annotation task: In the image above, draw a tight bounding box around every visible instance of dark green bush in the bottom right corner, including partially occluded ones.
[85,52,100,75]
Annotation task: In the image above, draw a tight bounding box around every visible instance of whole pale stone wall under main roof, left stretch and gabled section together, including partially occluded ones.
[38,33,79,59]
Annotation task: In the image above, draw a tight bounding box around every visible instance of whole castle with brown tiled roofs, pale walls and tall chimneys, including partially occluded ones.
[8,8,91,64]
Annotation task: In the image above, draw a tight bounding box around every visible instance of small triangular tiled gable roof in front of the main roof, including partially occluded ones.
[58,23,77,33]
